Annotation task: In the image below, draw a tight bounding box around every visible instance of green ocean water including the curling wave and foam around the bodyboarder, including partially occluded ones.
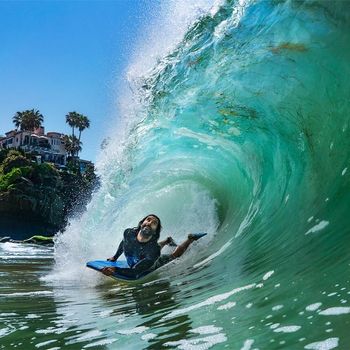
[0,0,350,350]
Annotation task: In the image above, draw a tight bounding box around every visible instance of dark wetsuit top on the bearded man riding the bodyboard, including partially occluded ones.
[113,228,160,276]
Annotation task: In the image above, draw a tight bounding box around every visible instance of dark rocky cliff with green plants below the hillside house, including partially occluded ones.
[0,151,97,239]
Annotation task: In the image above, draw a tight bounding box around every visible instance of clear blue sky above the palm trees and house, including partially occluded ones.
[0,0,157,161]
